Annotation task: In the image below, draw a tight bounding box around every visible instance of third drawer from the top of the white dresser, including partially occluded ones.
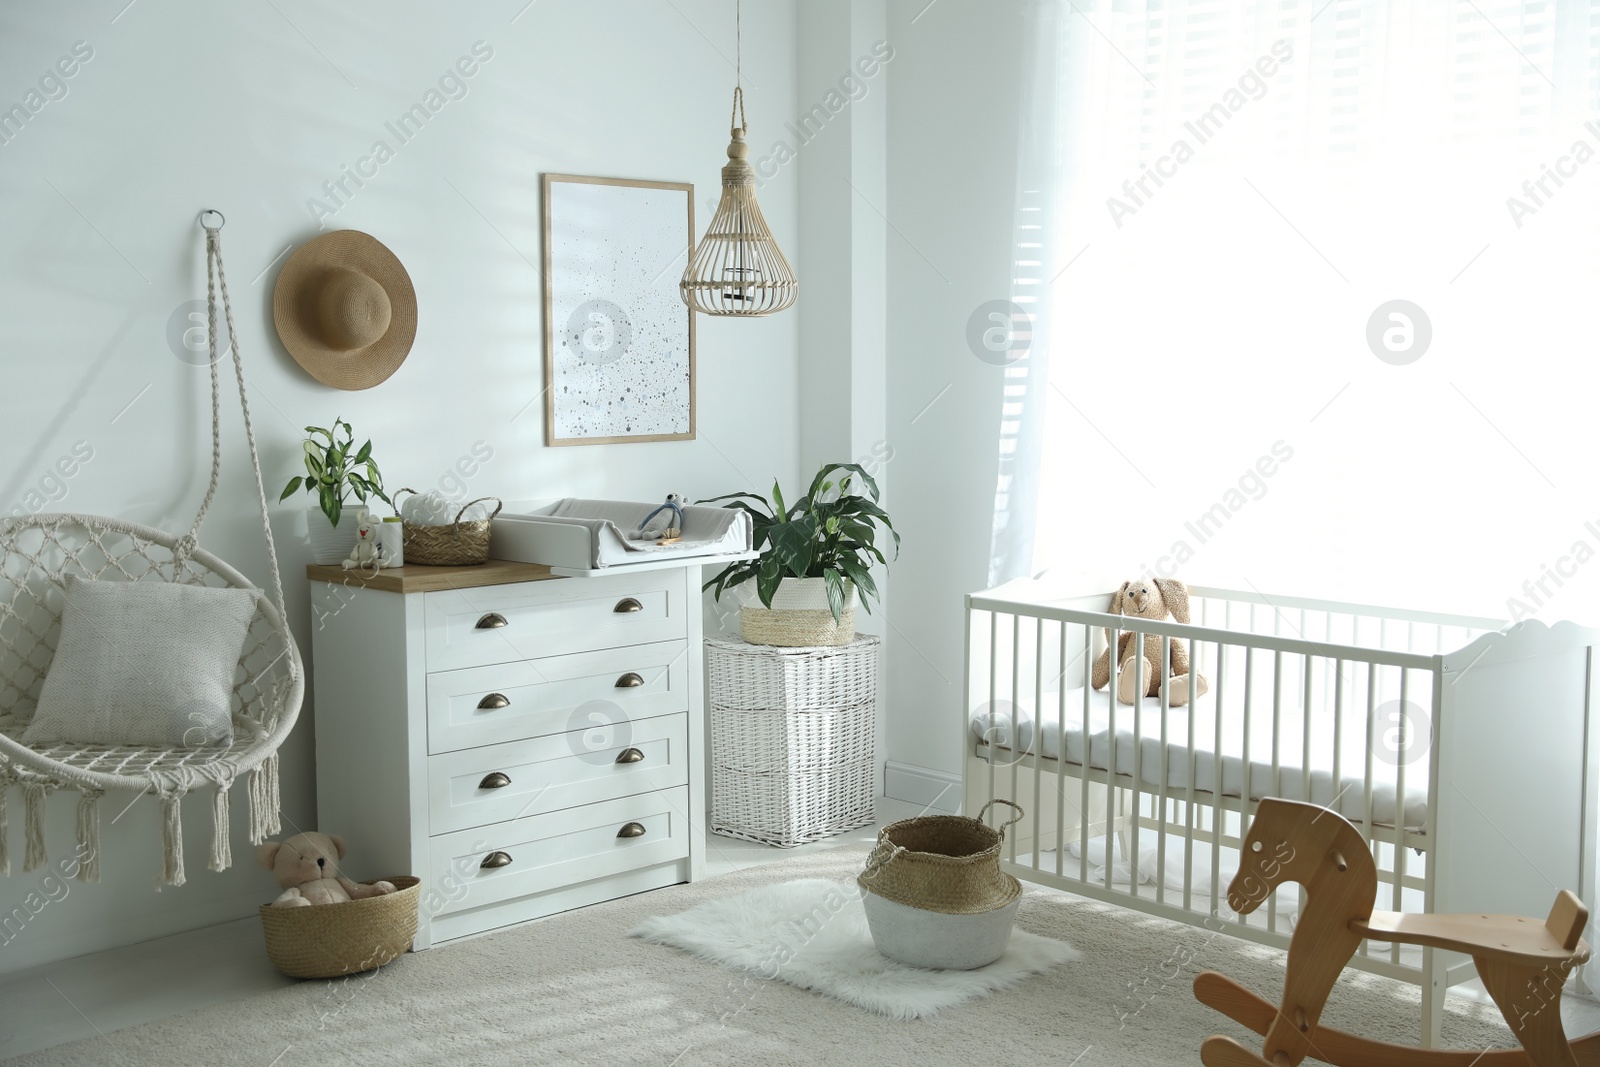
[427,715,690,833]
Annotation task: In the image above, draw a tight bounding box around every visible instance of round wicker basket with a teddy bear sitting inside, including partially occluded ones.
[256,833,422,977]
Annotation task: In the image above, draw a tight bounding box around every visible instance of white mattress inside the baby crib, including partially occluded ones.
[971,686,1427,830]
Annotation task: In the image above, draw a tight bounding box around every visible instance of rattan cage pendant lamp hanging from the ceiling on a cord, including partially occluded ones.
[678,0,800,315]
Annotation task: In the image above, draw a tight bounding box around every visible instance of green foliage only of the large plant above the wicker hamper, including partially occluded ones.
[701,464,899,624]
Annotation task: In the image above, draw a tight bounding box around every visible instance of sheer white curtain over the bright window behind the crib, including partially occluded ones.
[995,0,1600,621]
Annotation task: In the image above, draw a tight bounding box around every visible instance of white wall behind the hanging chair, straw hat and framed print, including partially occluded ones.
[0,0,800,971]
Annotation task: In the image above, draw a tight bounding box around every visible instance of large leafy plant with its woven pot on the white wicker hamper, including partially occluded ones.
[701,464,899,646]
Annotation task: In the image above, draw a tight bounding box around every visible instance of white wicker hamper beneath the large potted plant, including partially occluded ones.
[706,633,878,848]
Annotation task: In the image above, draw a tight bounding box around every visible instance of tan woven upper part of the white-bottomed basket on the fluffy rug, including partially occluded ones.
[856,800,1022,915]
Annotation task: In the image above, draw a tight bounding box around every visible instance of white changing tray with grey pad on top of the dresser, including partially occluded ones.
[490,498,752,571]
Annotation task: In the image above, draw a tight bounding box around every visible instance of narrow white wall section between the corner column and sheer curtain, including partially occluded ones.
[885,0,1022,806]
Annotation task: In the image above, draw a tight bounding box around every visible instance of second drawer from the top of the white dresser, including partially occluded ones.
[427,641,690,753]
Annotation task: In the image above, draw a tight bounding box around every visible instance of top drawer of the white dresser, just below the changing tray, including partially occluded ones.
[422,569,684,672]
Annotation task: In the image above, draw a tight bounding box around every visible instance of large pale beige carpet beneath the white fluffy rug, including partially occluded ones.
[0,846,1515,1067]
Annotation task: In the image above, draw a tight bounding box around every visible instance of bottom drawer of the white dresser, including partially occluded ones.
[429,787,690,913]
